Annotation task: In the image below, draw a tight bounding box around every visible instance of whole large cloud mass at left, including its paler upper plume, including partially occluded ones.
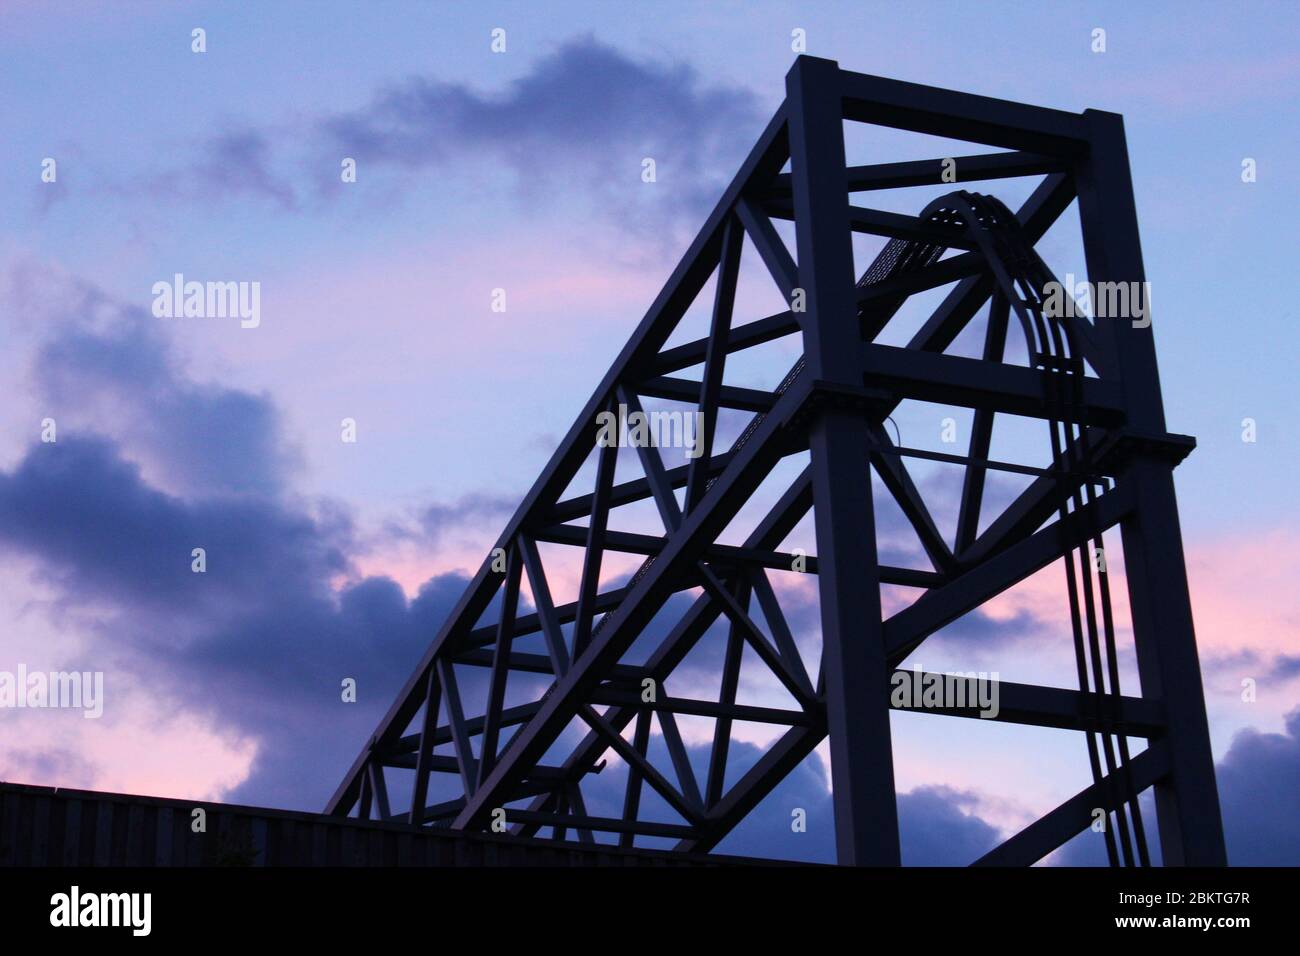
[0,267,491,809]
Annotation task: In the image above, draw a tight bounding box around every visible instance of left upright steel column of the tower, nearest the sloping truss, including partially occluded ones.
[785,57,901,866]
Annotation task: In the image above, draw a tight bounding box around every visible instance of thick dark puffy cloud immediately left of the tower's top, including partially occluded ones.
[322,36,763,226]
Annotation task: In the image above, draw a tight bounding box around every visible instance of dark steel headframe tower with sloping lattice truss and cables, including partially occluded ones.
[326,57,1226,865]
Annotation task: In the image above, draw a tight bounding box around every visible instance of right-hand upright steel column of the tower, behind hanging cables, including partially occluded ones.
[1076,109,1227,866]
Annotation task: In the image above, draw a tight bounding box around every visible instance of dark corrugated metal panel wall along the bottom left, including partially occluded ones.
[0,783,766,866]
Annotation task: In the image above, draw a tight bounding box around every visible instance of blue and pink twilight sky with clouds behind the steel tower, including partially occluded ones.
[0,0,1300,864]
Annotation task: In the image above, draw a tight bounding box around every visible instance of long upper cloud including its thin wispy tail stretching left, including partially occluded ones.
[68,36,766,241]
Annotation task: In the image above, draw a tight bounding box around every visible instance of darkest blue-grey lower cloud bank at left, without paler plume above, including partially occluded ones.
[0,437,467,808]
